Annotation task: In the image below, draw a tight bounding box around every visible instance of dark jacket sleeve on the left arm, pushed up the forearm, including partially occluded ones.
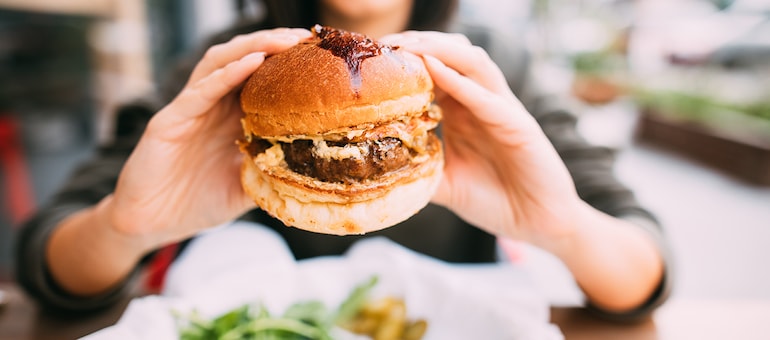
[15,104,154,311]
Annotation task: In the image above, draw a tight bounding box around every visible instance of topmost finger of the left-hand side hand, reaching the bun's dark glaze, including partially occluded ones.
[189,28,312,84]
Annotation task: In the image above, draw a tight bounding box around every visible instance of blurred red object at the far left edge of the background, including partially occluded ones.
[0,115,35,226]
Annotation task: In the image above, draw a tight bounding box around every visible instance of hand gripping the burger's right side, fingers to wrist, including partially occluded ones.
[381,32,584,247]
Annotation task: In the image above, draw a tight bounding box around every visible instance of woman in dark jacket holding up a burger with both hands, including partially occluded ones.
[17,0,671,318]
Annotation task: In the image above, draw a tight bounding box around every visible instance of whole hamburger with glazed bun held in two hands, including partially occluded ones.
[238,25,443,235]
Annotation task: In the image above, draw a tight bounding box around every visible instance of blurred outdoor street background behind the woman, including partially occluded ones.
[0,0,770,303]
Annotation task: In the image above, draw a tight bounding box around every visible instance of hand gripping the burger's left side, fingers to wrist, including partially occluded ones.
[107,29,310,249]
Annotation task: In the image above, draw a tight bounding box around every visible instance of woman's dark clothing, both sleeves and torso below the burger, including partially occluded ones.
[17,21,670,317]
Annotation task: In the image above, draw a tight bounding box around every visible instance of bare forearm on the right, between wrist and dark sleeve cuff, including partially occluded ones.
[547,204,664,312]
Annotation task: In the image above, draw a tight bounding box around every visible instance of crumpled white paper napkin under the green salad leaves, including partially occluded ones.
[85,222,563,340]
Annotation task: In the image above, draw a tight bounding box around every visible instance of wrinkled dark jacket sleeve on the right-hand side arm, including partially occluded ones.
[459,25,673,321]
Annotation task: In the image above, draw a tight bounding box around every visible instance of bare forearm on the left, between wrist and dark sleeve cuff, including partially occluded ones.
[45,196,148,296]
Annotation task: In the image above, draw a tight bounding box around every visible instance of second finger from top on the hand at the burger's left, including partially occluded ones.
[174,52,265,118]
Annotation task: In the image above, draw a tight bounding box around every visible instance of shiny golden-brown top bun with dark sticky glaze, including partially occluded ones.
[241,25,433,137]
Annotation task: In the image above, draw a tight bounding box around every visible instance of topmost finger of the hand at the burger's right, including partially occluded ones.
[394,32,510,95]
